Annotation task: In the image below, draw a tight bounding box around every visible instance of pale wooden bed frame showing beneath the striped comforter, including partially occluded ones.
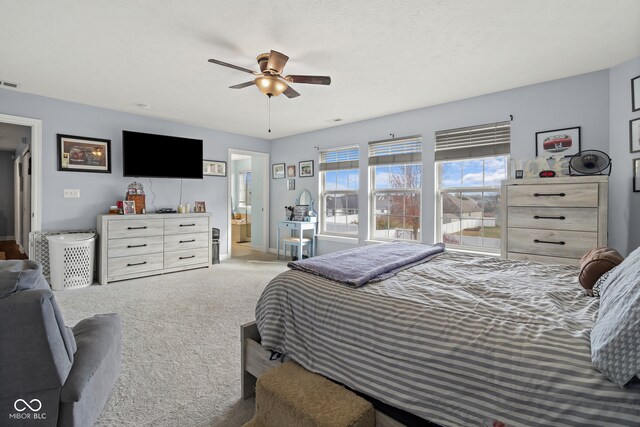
[240,322,404,427]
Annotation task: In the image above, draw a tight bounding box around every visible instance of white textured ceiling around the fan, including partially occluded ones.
[0,0,640,139]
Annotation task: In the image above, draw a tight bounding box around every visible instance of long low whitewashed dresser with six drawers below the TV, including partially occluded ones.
[97,213,212,285]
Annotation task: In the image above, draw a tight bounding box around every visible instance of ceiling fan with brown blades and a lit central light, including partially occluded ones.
[209,50,331,98]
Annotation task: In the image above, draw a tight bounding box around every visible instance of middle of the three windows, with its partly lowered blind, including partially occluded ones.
[369,136,422,241]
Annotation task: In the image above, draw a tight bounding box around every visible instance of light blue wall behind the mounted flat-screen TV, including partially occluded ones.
[0,89,269,254]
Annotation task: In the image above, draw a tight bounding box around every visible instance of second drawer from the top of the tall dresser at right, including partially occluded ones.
[508,206,598,232]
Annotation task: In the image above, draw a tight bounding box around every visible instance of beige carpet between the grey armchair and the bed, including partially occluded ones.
[55,254,287,427]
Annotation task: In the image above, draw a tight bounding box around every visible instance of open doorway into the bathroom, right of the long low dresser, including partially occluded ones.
[227,149,269,258]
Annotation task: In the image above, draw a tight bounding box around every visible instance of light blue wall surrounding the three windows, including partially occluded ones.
[270,70,609,253]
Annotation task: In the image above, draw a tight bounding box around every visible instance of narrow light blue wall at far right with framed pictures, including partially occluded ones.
[609,57,640,255]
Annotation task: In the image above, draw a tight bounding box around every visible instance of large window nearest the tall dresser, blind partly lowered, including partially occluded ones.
[436,122,511,253]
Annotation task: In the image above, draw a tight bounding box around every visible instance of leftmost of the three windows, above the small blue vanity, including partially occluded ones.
[319,147,360,237]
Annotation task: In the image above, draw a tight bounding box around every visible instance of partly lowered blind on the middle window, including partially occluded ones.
[369,135,422,166]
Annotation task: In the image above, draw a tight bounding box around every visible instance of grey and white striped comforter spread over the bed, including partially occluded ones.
[256,252,640,426]
